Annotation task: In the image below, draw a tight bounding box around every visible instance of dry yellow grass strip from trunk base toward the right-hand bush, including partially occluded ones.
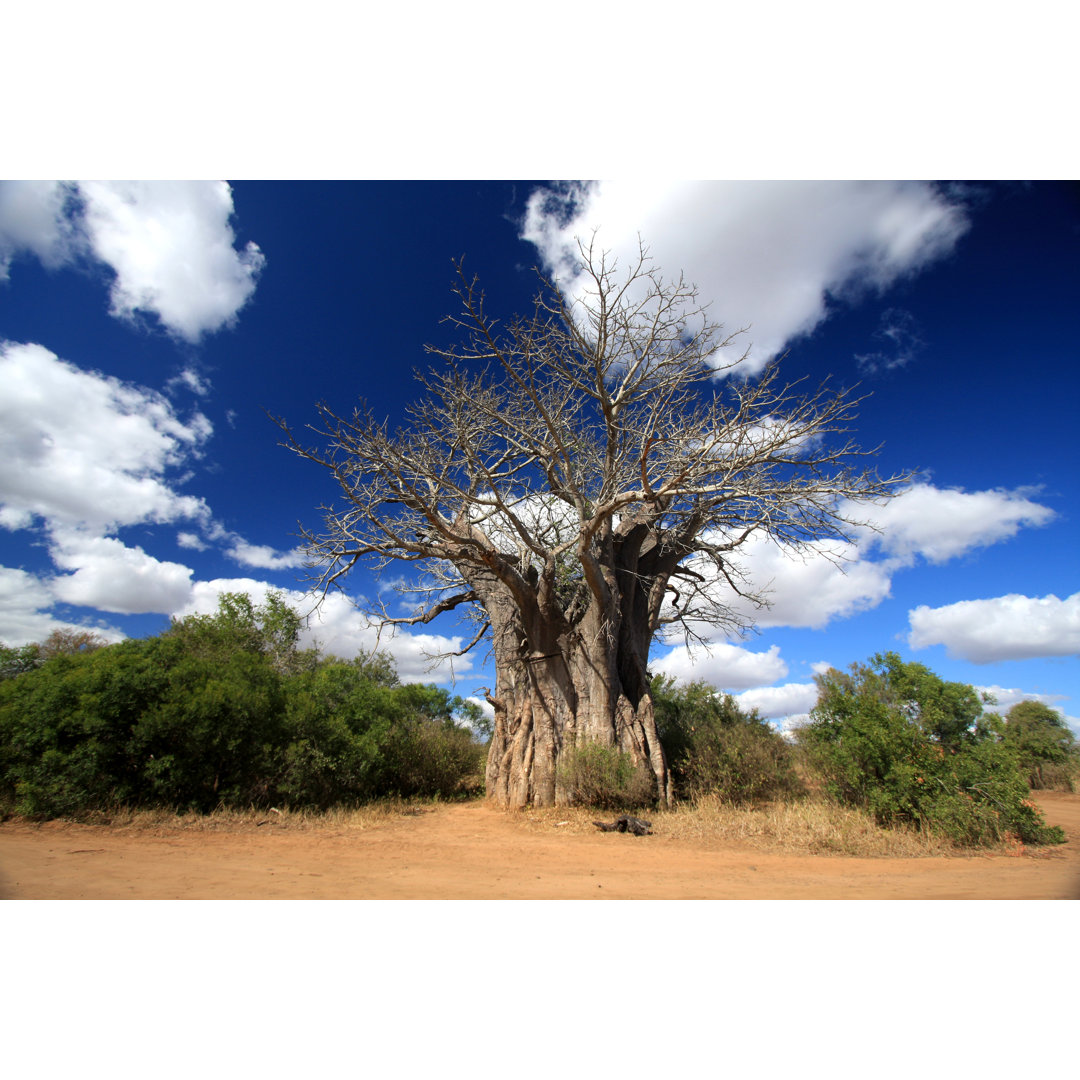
[522,796,972,859]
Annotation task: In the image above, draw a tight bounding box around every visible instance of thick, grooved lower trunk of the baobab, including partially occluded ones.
[487,618,672,808]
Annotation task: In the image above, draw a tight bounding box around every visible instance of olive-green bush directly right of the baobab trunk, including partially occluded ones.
[652,676,804,805]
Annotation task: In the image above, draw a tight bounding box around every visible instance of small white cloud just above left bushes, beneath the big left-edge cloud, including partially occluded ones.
[51,530,192,615]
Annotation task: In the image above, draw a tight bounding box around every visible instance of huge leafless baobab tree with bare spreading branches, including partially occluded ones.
[278,245,904,807]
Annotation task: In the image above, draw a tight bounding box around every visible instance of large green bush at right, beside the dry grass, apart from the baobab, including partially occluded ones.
[798,653,1065,847]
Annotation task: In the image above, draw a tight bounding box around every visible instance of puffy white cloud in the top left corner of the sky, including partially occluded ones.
[0,180,266,342]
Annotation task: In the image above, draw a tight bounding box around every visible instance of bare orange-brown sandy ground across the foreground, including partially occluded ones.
[0,792,1080,900]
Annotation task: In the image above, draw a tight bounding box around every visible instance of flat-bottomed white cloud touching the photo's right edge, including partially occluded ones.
[907,593,1080,664]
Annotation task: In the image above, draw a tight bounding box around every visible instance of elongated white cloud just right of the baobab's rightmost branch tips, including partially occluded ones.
[855,484,1056,564]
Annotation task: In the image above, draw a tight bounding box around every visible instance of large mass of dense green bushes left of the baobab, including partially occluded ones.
[0,594,483,816]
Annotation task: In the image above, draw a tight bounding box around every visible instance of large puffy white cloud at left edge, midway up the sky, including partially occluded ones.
[0,342,213,531]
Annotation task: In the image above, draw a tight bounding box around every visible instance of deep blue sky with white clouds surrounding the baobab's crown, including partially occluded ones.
[0,179,1080,727]
